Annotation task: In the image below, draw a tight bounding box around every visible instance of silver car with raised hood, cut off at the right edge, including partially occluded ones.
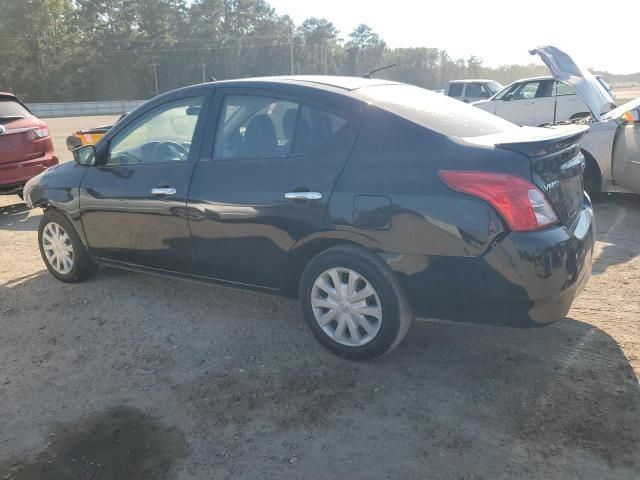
[484,46,640,194]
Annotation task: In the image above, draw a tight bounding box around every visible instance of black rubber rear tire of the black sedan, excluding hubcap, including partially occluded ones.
[299,245,413,360]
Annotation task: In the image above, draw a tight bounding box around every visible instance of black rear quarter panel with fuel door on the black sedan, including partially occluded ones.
[328,106,531,257]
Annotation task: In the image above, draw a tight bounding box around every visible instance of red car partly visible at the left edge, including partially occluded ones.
[0,92,58,196]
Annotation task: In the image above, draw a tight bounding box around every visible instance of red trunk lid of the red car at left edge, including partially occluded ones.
[0,117,46,164]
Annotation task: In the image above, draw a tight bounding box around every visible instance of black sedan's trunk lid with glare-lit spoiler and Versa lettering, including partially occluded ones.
[465,125,589,228]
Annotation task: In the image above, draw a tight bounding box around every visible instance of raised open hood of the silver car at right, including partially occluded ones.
[529,45,615,121]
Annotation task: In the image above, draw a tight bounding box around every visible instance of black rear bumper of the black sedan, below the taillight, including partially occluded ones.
[387,203,595,325]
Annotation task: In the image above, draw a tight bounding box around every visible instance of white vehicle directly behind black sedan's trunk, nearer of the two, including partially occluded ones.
[473,77,590,127]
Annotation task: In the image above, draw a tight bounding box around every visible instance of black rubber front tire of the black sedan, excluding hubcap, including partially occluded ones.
[38,210,98,283]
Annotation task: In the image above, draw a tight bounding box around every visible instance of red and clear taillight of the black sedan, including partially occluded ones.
[440,170,558,232]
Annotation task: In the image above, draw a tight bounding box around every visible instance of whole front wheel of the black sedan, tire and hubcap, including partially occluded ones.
[38,210,97,282]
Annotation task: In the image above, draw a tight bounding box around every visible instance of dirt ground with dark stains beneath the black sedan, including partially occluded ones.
[0,119,640,480]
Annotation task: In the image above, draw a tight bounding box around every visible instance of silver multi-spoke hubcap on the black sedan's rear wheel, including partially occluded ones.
[311,268,382,347]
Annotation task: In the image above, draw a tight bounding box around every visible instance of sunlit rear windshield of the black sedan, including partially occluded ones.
[353,84,518,137]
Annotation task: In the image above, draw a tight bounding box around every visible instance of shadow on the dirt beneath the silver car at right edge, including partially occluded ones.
[593,194,640,275]
